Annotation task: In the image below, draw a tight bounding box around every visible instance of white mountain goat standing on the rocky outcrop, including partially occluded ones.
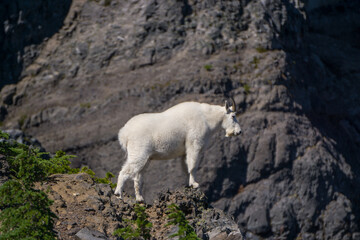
[115,99,241,201]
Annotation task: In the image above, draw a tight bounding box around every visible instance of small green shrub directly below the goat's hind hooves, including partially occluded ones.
[113,203,152,239]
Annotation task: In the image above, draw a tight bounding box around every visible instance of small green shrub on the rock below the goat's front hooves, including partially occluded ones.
[167,204,200,240]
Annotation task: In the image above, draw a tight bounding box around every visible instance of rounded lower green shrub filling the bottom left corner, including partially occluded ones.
[0,179,56,240]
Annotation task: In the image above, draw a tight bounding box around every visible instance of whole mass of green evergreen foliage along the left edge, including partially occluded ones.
[0,131,79,240]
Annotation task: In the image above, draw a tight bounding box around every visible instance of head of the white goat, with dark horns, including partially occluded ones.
[222,98,241,137]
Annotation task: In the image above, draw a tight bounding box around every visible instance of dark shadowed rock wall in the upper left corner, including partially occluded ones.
[0,0,71,89]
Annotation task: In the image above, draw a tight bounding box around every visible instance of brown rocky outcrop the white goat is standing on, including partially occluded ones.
[38,173,242,240]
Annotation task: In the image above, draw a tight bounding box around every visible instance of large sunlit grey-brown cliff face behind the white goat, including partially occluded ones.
[0,0,360,239]
